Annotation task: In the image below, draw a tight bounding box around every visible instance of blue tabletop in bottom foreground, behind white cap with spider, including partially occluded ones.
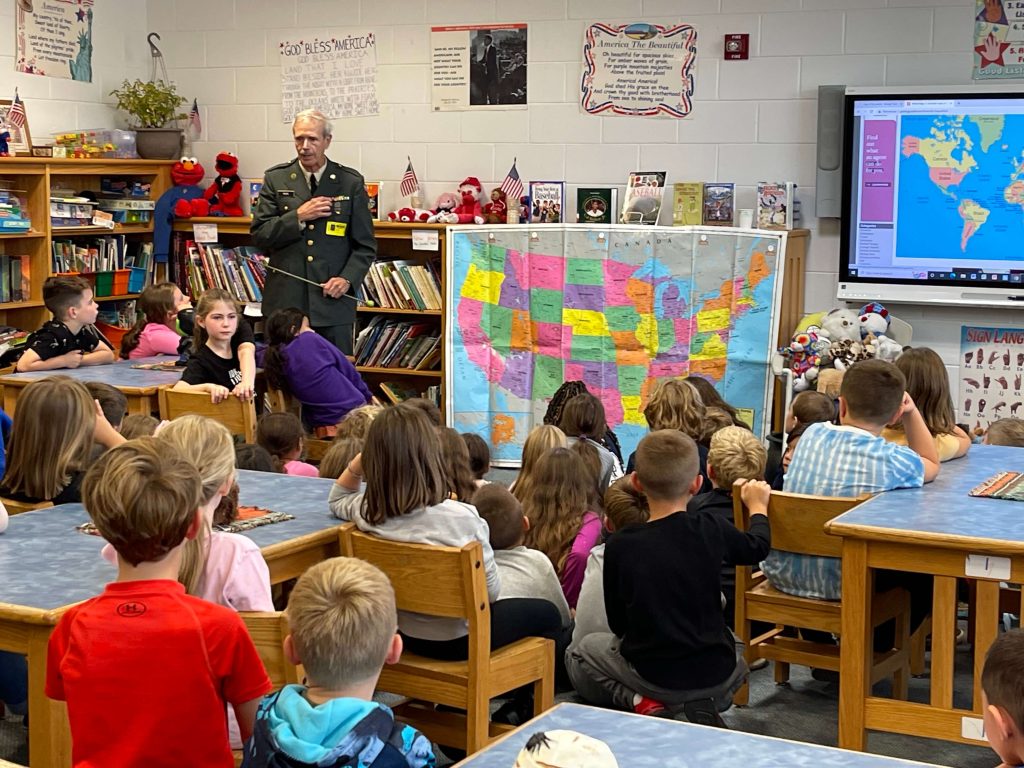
[459,703,927,768]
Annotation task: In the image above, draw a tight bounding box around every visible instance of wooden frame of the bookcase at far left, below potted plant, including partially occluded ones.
[0,158,173,331]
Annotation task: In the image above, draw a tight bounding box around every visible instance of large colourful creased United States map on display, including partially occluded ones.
[446,226,782,465]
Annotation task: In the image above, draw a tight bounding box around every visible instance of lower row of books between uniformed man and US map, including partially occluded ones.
[354,314,441,371]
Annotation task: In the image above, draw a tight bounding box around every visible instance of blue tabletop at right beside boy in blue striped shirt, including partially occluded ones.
[831,445,1024,546]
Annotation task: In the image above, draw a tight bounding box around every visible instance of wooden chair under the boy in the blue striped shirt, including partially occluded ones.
[733,492,910,705]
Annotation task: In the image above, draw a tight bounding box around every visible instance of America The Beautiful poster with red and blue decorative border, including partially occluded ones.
[580,23,697,118]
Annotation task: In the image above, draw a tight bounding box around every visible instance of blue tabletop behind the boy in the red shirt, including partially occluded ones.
[0,470,342,610]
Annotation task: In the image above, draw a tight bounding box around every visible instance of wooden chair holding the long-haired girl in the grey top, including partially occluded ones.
[340,525,555,754]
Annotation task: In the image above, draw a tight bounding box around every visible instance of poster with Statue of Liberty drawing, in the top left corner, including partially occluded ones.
[14,0,93,83]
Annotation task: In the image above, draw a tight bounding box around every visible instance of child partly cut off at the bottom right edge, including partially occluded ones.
[981,630,1024,768]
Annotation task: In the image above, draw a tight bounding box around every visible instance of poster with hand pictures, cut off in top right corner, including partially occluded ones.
[974,0,1024,80]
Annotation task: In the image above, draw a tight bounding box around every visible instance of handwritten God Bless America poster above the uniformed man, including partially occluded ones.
[278,31,380,123]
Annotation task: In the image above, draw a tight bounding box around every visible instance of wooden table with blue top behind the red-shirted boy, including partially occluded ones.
[0,470,343,768]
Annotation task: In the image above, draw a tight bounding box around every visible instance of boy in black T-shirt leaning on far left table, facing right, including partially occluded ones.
[17,275,114,371]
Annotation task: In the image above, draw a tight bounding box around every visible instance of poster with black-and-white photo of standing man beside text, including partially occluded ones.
[430,24,527,112]
